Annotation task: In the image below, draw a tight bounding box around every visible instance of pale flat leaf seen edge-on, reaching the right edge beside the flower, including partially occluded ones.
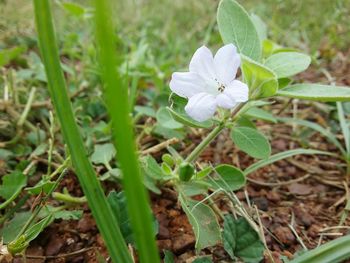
[276,84,350,101]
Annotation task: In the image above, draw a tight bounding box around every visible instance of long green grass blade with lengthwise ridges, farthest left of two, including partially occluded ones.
[34,0,132,263]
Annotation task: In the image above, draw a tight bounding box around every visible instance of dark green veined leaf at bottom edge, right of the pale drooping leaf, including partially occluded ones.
[223,215,265,263]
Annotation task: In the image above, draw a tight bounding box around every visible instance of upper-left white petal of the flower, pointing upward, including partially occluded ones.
[189,46,216,80]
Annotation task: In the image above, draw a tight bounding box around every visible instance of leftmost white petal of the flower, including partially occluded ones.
[169,72,206,98]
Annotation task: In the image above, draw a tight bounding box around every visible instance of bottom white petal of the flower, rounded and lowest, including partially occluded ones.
[185,92,216,121]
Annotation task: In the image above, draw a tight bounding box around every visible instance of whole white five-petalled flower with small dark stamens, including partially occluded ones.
[169,44,249,121]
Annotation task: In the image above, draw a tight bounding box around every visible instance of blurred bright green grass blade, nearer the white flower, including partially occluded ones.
[94,0,160,263]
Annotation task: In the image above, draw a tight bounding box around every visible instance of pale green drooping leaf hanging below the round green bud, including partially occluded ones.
[179,194,221,251]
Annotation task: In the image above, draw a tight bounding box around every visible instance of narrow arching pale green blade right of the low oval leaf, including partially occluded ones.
[244,149,333,176]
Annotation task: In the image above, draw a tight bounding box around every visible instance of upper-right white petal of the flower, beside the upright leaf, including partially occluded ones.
[214,44,241,85]
